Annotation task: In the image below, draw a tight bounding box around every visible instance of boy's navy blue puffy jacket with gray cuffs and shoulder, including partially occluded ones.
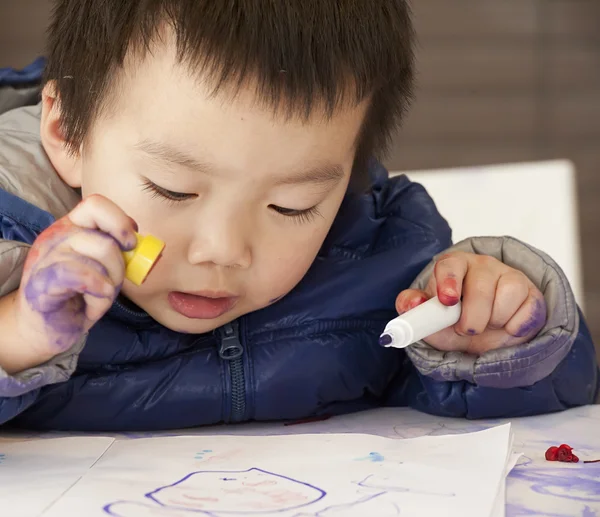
[0,61,598,431]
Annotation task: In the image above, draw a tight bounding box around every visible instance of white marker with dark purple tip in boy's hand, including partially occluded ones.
[379,296,461,348]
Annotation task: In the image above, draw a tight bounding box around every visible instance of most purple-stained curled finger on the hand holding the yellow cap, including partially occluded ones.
[24,257,116,314]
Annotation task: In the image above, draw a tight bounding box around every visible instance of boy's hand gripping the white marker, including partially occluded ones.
[396,252,546,355]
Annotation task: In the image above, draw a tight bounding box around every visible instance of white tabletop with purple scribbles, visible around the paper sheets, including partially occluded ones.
[0,406,600,517]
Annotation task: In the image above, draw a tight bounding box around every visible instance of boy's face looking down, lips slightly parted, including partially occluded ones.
[59,40,366,333]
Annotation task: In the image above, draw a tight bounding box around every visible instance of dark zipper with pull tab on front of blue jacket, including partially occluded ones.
[219,321,246,422]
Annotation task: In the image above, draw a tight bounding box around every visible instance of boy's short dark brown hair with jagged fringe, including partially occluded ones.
[45,0,414,176]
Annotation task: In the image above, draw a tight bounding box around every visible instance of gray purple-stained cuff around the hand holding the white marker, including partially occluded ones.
[406,237,579,388]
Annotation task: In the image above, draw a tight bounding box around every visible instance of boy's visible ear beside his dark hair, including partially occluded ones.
[40,81,81,188]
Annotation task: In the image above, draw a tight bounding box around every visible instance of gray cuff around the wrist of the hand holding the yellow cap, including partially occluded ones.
[0,239,87,397]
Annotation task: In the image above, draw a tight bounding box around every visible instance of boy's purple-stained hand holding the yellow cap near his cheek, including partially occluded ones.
[15,195,136,363]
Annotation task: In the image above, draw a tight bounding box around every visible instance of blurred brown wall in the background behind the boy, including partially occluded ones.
[0,0,600,344]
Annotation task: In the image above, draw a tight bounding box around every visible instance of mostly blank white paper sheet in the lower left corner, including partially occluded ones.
[0,438,114,517]
